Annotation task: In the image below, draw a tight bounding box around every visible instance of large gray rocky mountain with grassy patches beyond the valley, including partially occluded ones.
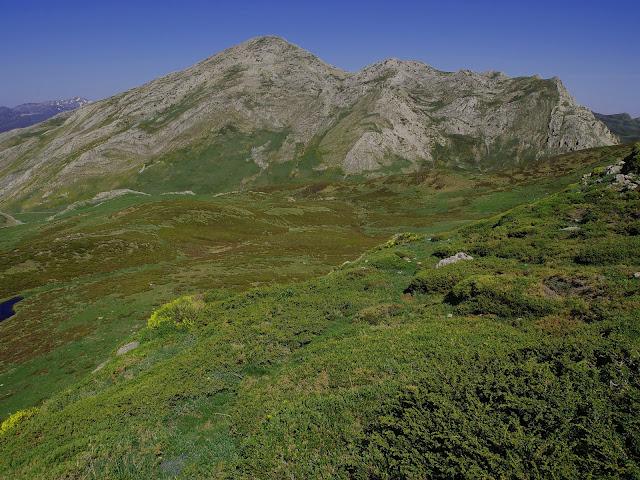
[0,33,617,208]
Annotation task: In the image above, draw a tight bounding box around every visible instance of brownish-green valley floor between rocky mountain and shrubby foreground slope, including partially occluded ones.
[0,143,629,418]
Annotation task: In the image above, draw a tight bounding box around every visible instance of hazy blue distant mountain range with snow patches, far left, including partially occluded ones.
[0,97,89,132]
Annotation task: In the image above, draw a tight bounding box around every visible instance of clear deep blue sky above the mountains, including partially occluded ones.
[0,0,640,116]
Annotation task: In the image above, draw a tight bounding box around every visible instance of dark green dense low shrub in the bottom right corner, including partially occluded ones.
[358,347,639,479]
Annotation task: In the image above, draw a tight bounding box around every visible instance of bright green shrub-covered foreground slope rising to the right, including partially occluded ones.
[0,145,640,478]
